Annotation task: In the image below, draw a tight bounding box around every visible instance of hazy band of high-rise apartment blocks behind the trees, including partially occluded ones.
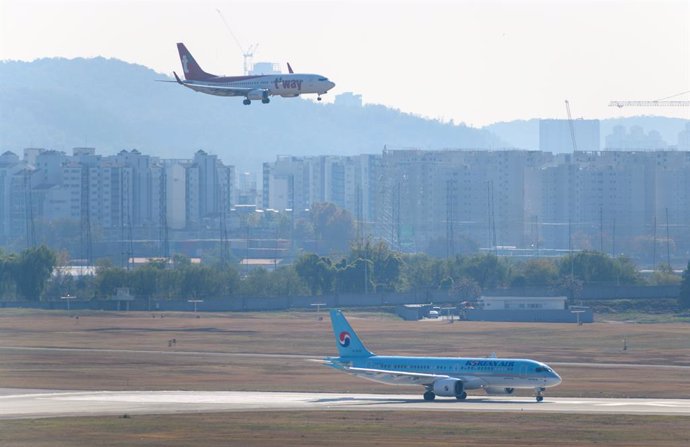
[0,144,690,265]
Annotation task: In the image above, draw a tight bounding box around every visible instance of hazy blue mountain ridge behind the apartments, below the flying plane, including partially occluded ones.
[0,57,505,169]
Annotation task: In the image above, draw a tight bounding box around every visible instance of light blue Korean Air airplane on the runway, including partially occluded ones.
[325,309,561,402]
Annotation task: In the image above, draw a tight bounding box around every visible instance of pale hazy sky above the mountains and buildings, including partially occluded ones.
[0,0,690,126]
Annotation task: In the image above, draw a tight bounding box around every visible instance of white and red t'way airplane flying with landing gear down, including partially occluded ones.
[173,43,335,105]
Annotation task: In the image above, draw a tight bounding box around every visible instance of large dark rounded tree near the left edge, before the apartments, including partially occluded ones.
[12,245,56,301]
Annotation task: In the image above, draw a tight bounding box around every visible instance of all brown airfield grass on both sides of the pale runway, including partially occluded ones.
[0,310,690,447]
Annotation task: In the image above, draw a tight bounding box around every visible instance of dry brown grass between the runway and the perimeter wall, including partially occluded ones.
[0,310,690,398]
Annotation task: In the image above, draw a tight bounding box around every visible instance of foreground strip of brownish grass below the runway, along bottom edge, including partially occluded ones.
[0,411,690,447]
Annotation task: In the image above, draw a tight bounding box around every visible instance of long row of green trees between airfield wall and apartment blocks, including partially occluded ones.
[0,245,690,307]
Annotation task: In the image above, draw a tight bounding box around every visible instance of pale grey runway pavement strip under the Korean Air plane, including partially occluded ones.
[0,389,690,419]
